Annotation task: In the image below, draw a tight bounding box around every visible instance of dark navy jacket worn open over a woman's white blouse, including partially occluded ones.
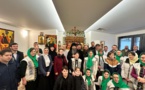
[38,55,52,76]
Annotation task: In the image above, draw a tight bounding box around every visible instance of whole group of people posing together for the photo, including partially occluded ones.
[0,42,145,90]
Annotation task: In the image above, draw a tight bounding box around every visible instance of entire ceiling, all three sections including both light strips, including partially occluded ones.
[0,0,145,34]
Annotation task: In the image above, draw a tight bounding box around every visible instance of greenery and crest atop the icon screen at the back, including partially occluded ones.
[66,27,84,37]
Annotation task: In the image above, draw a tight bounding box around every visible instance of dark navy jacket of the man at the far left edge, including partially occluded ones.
[0,60,18,90]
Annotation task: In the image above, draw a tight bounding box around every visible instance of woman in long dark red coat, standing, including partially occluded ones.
[54,49,67,77]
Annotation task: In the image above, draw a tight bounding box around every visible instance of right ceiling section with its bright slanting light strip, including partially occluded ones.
[86,0,145,34]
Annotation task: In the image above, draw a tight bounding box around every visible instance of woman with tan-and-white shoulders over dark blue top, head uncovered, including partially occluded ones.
[104,52,121,75]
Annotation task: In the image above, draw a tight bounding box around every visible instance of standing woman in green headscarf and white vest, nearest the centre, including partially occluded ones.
[83,51,98,77]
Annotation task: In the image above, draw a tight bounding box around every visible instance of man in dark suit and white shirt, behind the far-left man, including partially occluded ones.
[10,43,24,67]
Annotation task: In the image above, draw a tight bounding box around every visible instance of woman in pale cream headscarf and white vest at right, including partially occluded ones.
[121,52,139,89]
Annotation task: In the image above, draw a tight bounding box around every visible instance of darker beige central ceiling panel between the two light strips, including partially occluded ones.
[53,0,121,30]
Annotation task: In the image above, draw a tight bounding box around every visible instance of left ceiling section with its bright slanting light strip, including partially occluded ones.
[0,0,64,31]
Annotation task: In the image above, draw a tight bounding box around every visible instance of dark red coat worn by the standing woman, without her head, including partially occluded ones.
[54,55,68,74]
